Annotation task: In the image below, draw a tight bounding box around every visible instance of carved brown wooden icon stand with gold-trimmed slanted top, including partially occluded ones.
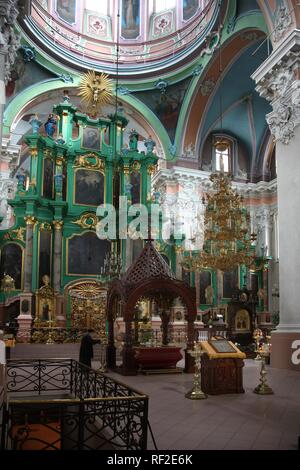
[201,340,246,395]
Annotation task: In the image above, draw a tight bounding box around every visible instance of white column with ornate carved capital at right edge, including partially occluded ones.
[252,30,300,370]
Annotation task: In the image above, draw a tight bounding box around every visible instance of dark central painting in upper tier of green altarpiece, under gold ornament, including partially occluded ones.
[74,169,104,206]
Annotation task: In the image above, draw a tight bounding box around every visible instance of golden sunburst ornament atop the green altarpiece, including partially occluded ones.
[78,70,113,113]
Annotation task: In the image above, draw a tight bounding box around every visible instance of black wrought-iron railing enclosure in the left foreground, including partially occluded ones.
[2,359,148,450]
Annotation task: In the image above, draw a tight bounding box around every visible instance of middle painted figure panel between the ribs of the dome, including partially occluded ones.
[121,0,140,39]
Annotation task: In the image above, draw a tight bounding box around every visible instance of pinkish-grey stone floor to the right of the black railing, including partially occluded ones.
[105,360,300,450]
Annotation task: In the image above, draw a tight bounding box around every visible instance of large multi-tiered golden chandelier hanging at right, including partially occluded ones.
[182,171,256,271]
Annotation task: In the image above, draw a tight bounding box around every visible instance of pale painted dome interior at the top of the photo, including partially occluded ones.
[21,0,218,76]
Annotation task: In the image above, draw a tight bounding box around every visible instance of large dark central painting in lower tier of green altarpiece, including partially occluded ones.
[67,232,110,275]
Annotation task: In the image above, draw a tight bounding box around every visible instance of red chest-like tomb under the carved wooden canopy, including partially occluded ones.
[134,346,183,373]
